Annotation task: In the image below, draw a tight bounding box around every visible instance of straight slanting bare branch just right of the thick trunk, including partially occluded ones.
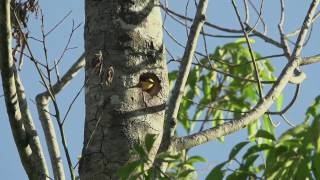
[164,0,208,148]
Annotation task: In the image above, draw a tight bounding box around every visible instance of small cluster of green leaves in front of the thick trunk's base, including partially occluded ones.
[118,134,206,180]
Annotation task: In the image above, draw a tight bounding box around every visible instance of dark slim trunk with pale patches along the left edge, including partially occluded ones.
[0,0,48,179]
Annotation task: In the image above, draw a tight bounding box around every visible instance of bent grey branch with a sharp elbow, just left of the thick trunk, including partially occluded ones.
[36,54,85,180]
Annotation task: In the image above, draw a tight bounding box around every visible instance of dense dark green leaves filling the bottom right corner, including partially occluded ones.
[207,96,320,179]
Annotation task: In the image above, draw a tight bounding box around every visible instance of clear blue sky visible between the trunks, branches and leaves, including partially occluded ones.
[0,0,320,180]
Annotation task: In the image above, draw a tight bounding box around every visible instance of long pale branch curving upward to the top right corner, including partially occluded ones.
[172,0,320,151]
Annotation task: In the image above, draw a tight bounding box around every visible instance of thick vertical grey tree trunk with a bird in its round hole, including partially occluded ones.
[79,0,169,179]
